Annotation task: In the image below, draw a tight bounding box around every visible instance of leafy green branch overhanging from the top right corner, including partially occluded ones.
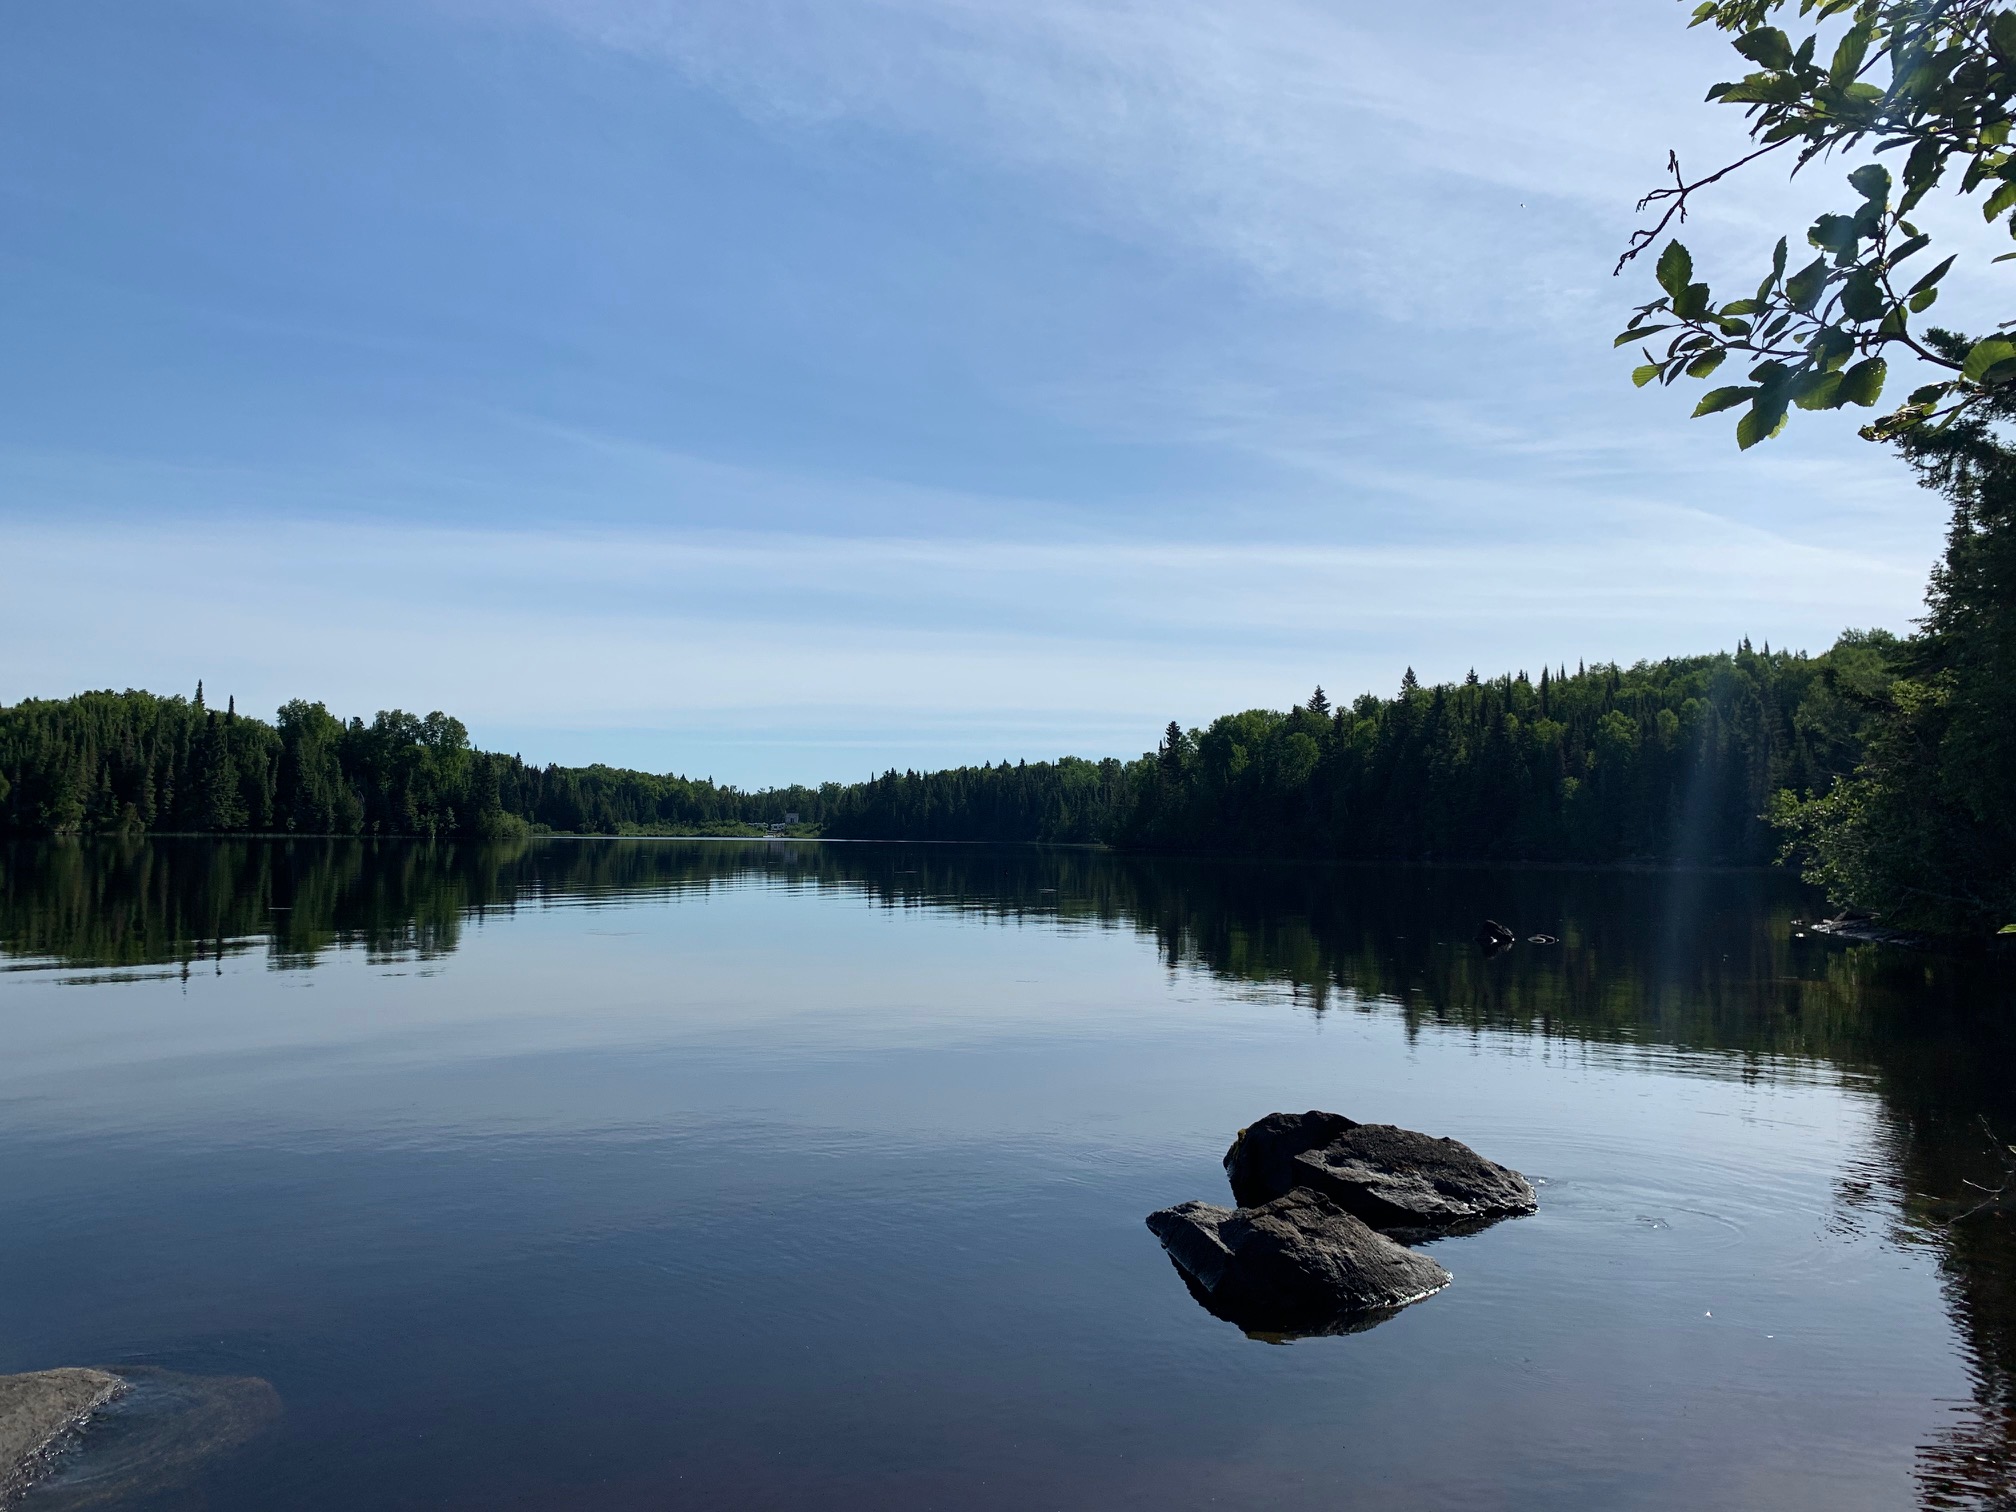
[1617,0,2016,448]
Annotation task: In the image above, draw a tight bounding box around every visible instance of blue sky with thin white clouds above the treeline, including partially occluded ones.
[0,0,1974,786]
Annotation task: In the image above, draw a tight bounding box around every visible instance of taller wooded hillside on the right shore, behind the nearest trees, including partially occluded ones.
[1115,635,1891,863]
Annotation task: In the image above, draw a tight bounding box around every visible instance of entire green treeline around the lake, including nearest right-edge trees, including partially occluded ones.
[0,608,2016,939]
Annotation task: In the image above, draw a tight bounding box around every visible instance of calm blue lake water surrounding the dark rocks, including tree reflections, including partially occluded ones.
[0,841,2016,1512]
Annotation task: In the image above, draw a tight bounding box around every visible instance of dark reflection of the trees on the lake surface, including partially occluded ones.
[0,839,2016,1508]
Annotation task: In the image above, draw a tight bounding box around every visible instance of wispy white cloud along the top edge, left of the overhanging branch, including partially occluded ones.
[471,0,1766,327]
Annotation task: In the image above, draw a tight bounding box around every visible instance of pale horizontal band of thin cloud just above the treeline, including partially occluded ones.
[0,508,1917,782]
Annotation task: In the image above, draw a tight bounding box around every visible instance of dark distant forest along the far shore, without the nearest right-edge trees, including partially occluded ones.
[0,633,1895,865]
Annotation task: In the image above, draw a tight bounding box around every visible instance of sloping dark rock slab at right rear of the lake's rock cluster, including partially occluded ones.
[1294,1123,1540,1234]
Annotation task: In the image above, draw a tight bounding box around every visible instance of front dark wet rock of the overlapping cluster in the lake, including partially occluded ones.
[1147,1189,1450,1333]
